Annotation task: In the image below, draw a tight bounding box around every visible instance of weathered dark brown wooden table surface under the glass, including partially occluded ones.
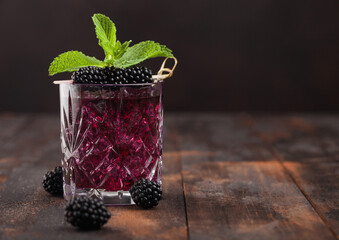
[0,114,339,240]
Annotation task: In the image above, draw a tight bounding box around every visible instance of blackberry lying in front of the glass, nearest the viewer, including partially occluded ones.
[65,197,111,230]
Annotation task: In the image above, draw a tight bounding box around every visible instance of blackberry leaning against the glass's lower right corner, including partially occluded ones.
[129,178,162,209]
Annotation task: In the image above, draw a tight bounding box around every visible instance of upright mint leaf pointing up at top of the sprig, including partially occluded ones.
[92,14,117,60]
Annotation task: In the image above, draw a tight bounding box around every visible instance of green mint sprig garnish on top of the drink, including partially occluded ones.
[49,14,173,75]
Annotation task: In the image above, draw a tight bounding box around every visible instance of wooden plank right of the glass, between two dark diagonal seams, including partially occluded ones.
[177,115,335,240]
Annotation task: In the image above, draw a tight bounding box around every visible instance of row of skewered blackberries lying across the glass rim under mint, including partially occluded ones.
[71,66,153,84]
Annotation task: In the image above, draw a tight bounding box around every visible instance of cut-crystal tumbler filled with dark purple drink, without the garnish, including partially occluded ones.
[60,83,163,204]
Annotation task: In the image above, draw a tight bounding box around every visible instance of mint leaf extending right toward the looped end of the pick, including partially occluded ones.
[113,41,173,68]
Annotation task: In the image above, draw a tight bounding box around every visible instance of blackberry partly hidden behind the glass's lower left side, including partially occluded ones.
[42,166,63,195]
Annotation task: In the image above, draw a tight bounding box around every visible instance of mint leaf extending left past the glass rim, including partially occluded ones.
[48,51,105,76]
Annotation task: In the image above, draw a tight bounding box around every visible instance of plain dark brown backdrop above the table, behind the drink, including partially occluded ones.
[0,0,339,112]
